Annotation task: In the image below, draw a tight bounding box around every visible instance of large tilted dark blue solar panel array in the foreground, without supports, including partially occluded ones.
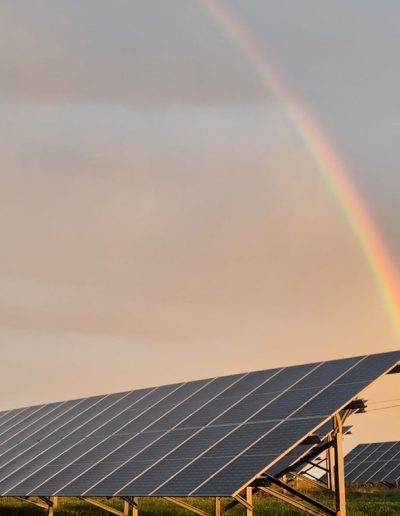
[0,352,400,496]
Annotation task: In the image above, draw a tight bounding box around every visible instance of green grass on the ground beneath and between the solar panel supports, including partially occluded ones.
[0,488,400,516]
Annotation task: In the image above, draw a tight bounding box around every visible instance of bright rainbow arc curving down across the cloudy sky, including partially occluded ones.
[200,0,400,340]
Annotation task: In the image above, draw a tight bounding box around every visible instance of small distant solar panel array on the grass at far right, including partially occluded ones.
[345,441,400,484]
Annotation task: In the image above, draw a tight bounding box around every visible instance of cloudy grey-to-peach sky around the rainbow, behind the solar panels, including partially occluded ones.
[0,0,400,445]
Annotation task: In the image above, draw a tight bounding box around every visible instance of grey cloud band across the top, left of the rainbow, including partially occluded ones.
[0,0,265,106]
